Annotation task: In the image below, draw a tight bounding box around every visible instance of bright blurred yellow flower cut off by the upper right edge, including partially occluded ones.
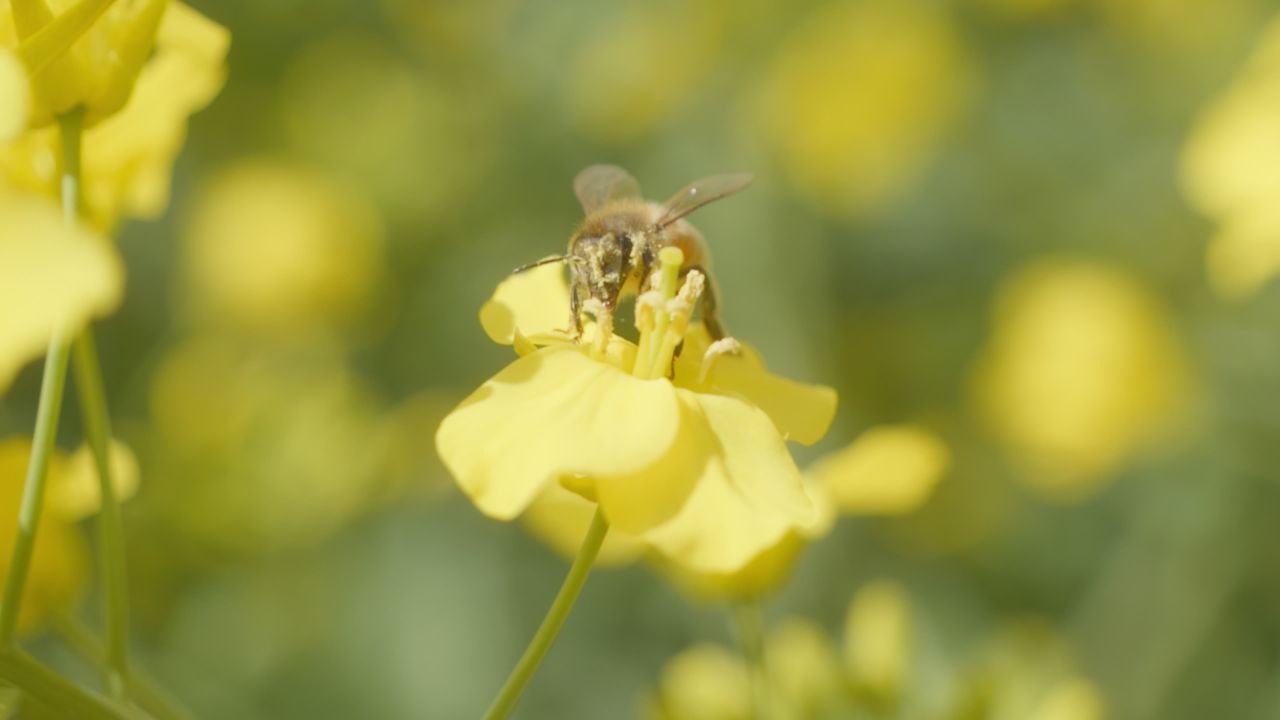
[1183,17,1280,297]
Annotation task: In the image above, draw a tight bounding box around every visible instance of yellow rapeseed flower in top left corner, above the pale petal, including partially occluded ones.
[0,0,229,232]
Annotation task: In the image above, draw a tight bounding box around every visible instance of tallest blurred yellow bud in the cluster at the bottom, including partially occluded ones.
[845,580,914,698]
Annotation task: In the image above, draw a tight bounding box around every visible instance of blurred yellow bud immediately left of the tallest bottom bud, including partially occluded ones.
[765,618,845,717]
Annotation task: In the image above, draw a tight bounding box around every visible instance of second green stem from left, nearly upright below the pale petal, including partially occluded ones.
[72,328,129,700]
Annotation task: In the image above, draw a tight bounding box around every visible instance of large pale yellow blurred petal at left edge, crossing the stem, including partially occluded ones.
[0,192,123,391]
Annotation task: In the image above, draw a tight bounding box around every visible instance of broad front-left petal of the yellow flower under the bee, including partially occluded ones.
[435,347,680,520]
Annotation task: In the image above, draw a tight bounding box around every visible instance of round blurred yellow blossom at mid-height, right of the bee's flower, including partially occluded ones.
[972,259,1190,500]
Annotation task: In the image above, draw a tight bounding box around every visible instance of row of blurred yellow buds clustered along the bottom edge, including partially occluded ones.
[644,580,1105,720]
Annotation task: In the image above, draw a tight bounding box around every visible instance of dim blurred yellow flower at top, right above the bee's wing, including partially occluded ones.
[749,0,970,217]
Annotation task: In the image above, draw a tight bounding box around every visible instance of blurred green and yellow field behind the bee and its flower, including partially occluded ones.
[0,0,1280,720]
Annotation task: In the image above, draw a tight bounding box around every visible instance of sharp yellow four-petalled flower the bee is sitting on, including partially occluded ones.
[436,249,835,573]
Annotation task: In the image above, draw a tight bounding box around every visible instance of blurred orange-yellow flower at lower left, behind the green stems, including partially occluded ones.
[0,437,137,633]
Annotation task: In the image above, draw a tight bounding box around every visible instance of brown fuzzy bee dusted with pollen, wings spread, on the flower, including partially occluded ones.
[515,165,751,340]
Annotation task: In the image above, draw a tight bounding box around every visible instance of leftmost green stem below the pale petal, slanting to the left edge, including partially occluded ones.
[0,329,67,652]
